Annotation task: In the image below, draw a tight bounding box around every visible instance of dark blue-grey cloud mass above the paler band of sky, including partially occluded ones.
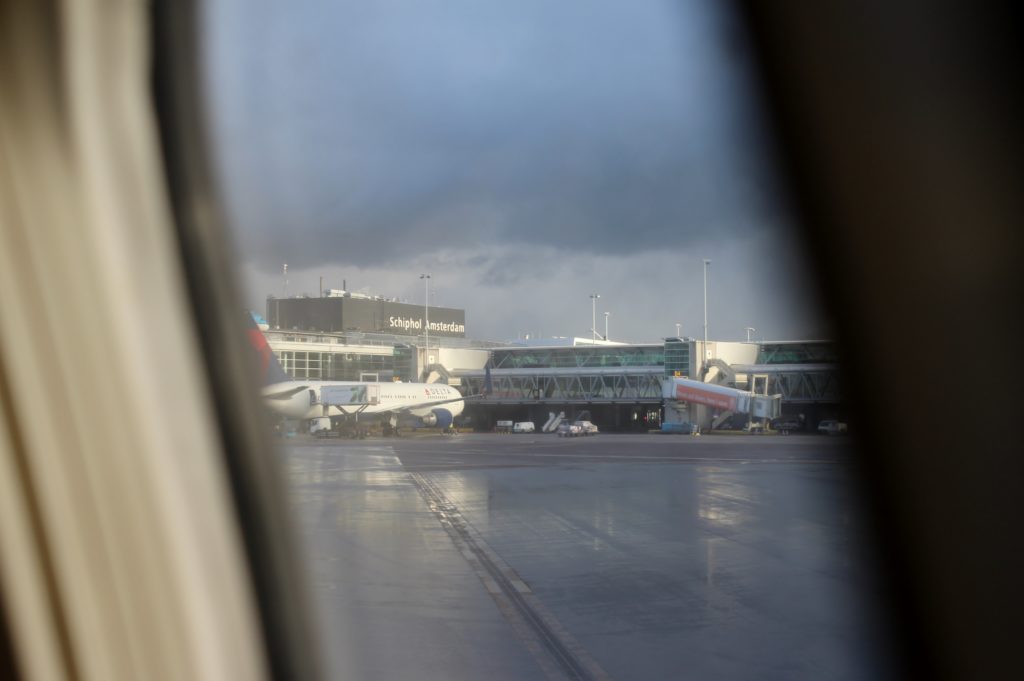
[209,0,777,274]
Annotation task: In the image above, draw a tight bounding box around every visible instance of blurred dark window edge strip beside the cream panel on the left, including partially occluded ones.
[151,5,324,679]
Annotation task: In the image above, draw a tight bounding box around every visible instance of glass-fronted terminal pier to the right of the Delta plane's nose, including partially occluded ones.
[451,338,842,430]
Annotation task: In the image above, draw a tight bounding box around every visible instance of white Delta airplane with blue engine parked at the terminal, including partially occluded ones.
[249,317,490,433]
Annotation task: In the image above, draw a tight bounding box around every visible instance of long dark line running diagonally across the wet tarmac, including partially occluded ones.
[410,473,612,681]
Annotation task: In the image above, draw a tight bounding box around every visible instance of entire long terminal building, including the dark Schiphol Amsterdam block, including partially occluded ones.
[260,293,843,431]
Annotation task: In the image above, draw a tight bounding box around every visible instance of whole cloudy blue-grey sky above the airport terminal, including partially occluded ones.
[204,0,827,342]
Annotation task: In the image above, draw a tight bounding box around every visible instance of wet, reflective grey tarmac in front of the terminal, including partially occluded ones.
[281,433,891,681]
